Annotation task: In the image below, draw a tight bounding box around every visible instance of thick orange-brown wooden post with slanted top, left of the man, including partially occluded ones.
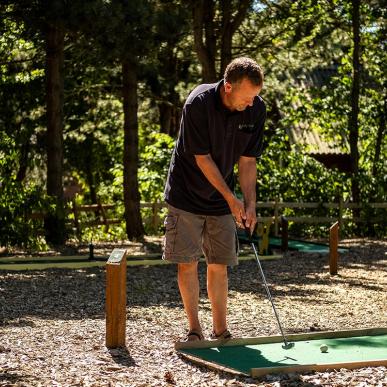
[106,249,126,348]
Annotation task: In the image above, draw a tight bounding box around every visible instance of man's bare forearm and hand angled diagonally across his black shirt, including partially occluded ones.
[195,154,246,223]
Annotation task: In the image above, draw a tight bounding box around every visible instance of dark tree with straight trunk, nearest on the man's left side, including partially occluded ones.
[90,0,154,240]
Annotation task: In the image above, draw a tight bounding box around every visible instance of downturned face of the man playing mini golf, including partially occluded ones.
[224,78,262,112]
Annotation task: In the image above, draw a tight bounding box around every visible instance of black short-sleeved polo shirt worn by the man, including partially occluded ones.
[164,80,266,215]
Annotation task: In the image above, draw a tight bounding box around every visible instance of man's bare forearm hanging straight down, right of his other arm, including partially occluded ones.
[238,156,257,232]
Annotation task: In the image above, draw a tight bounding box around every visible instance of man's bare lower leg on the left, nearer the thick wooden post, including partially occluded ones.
[177,262,202,333]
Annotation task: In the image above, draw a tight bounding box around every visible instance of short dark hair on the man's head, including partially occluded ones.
[224,57,263,86]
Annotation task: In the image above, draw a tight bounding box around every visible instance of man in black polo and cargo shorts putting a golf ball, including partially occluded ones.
[163,58,266,341]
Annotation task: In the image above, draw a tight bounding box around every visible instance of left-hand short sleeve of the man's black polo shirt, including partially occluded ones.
[181,98,210,155]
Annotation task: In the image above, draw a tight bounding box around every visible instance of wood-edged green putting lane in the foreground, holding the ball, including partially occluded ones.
[175,328,387,376]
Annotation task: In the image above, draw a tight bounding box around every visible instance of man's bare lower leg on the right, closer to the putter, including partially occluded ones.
[207,263,228,335]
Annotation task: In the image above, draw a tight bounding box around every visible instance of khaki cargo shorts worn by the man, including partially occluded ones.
[163,205,239,266]
